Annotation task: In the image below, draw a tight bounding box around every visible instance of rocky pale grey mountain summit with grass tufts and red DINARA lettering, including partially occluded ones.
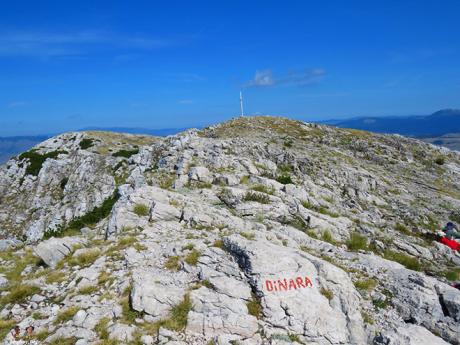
[0,117,460,345]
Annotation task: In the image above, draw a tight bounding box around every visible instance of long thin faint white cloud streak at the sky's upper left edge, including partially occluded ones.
[0,30,177,58]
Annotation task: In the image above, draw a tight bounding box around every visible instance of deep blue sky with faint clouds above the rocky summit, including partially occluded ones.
[0,0,460,136]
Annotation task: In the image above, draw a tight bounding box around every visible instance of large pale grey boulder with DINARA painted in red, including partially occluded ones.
[224,235,366,344]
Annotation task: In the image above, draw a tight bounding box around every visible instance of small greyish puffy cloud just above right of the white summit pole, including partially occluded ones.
[245,68,326,87]
